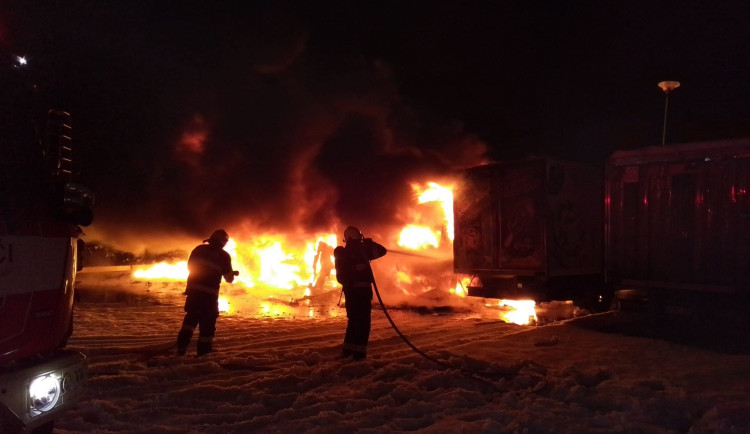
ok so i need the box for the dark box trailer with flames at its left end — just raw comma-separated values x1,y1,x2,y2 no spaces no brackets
453,157,610,318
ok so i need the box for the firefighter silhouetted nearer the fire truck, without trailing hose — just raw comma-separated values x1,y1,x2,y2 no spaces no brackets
177,229,240,356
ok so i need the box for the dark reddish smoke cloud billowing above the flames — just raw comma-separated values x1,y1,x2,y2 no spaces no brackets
76,5,487,248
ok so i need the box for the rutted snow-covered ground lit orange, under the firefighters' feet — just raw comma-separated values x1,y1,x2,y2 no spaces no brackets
55,280,750,433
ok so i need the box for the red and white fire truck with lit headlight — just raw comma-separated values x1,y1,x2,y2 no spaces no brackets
0,56,93,432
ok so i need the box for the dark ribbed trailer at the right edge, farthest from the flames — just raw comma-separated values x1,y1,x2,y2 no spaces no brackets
605,139,750,318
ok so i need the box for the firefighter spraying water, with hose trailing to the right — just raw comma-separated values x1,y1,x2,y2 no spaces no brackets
333,226,386,360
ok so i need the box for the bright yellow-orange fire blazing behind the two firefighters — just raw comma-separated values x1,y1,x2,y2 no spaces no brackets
79,182,564,324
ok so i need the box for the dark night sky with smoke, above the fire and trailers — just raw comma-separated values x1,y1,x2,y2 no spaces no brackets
0,0,750,248
